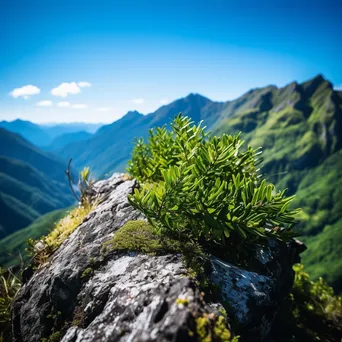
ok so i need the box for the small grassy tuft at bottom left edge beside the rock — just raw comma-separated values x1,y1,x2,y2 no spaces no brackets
0,267,21,341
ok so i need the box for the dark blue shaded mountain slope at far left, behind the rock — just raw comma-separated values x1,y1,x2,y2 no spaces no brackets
0,128,74,238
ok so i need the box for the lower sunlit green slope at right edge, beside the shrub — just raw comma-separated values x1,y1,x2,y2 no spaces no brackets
296,150,342,290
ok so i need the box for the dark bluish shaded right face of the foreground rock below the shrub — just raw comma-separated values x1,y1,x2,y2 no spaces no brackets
211,241,302,341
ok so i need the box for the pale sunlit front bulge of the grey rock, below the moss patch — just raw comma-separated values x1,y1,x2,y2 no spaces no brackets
62,255,203,342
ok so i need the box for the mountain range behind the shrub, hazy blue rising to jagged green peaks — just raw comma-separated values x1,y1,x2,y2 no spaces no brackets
0,75,342,290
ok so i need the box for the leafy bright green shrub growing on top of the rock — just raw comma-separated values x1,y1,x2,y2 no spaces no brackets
128,114,297,246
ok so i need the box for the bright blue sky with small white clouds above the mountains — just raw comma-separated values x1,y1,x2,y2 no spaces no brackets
0,0,342,122
